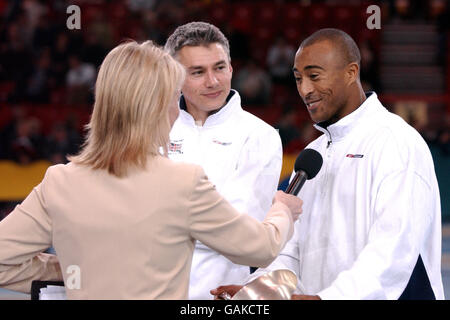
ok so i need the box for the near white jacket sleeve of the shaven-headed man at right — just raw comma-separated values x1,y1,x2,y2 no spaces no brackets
318,168,434,299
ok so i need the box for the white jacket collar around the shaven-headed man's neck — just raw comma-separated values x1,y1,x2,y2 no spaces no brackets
314,91,384,142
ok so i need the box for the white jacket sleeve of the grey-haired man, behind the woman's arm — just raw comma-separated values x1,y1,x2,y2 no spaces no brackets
221,129,283,221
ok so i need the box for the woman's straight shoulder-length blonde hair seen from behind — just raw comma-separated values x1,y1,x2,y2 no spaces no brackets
69,41,185,177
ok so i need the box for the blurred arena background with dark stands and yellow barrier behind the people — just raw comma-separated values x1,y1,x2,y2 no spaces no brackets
0,0,450,299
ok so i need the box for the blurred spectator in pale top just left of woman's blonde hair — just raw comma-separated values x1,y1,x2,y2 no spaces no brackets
66,54,96,104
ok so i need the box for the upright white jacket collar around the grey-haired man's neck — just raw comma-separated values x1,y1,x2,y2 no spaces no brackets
178,89,242,127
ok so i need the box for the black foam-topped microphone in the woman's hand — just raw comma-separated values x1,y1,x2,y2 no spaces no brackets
285,149,323,195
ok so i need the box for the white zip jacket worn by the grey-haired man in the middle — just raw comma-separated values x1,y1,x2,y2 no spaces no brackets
169,90,283,300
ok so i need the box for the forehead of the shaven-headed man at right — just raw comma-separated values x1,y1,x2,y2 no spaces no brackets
294,40,339,71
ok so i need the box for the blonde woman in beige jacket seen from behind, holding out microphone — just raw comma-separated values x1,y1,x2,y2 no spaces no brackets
0,41,302,299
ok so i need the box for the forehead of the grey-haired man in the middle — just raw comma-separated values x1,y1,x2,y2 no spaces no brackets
178,43,228,67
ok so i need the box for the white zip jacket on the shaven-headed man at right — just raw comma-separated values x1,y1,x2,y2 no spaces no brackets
248,93,444,299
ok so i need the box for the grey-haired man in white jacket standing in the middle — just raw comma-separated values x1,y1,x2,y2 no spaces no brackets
165,22,282,299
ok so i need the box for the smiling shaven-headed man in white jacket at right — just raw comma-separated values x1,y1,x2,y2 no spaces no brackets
212,29,444,299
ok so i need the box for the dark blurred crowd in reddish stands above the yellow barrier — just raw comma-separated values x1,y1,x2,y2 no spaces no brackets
0,0,450,164
